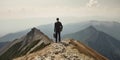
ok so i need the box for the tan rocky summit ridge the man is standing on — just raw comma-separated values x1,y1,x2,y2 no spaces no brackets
14,39,108,60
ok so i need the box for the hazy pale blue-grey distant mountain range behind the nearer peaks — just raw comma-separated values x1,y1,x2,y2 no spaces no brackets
0,21,120,42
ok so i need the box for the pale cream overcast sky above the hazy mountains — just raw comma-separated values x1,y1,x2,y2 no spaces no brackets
0,0,120,36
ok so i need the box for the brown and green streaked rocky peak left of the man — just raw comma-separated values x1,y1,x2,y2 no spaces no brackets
0,28,52,60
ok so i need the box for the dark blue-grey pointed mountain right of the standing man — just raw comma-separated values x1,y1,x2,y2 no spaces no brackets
65,26,120,60
